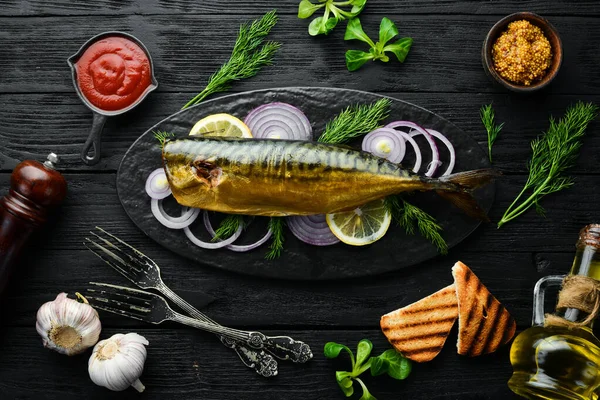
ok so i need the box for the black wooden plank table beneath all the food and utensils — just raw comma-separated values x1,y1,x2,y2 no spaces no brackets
0,0,600,400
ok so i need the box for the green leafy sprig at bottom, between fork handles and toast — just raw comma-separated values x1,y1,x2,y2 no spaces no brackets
323,339,412,400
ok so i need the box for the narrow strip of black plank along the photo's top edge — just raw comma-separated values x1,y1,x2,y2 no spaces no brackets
0,0,599,16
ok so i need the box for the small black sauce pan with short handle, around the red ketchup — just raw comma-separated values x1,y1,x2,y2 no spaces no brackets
67,31,158,165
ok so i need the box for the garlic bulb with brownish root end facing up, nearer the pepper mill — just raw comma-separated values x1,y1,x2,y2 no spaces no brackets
35,293,102,356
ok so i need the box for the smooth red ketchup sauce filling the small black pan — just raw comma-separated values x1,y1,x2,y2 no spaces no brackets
75,36,152,111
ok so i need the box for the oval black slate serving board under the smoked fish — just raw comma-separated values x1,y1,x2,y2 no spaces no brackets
117,88,495,280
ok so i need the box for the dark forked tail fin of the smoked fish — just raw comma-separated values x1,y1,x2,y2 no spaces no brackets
437,169,501,222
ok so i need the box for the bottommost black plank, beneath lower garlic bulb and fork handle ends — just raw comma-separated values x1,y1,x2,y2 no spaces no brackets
0,328,516,400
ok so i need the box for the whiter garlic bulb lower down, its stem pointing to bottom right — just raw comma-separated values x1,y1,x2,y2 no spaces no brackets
88,333,148,392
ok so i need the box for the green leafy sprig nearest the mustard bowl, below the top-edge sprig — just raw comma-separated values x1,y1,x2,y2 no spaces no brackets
344,17,413,71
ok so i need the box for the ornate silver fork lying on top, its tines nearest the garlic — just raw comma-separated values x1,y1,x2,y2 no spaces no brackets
86,282,312,363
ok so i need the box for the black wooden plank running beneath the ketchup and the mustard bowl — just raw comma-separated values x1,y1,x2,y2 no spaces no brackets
0,13,600,97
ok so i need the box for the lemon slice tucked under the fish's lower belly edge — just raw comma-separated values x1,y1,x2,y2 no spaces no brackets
326,199,392,246
